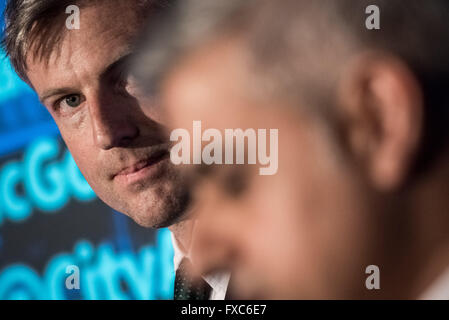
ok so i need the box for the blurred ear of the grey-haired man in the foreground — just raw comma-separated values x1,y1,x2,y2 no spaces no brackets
337,53,423,191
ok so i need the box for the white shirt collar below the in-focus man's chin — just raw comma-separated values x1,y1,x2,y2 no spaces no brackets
170,233,231,300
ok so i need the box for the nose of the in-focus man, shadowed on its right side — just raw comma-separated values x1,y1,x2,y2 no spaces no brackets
89,95,139,150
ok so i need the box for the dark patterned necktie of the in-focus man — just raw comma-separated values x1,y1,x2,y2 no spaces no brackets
174,258,212,300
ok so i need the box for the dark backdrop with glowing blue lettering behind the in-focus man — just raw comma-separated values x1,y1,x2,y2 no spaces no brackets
0,0,174,299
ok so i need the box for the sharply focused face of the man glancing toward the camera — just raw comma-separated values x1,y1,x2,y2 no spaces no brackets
27,0,187,227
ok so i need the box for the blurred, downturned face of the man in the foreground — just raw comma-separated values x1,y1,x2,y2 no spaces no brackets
162,41,382,298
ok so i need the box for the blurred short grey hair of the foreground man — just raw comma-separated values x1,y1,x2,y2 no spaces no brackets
135,0,449,175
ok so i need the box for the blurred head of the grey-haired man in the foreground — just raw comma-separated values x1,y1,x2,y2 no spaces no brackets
137,0,449,298
